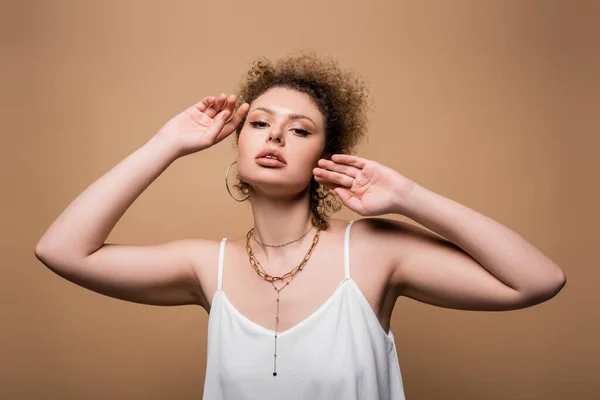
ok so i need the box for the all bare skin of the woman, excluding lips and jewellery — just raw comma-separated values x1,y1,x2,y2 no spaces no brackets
35,88,566,338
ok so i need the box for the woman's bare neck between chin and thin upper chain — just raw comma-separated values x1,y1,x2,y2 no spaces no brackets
250,186,312,245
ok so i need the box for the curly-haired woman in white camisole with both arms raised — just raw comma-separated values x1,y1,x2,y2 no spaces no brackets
36,55,565,399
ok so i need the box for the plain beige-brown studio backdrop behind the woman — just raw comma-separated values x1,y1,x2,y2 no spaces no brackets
0,0,600,400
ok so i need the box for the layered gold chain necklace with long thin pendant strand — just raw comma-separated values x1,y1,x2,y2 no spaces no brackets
246,226,321,376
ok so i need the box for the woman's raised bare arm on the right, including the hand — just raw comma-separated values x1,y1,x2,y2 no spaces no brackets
314,155,566,311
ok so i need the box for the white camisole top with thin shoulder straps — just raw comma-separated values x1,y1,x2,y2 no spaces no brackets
204,221,405,400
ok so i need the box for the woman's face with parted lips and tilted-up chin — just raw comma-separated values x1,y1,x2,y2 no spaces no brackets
238,87,325,196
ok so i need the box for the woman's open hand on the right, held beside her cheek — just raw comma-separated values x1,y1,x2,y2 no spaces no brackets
313,154,414,216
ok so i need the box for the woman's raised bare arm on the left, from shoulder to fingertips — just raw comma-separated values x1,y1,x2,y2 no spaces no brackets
35,94,248,306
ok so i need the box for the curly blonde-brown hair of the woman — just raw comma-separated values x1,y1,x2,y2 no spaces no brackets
235,53,371,229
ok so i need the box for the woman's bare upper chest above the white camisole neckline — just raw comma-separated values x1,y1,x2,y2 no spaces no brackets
209,238,395,333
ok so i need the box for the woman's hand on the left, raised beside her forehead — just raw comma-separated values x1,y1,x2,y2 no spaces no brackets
156,94,250,156
